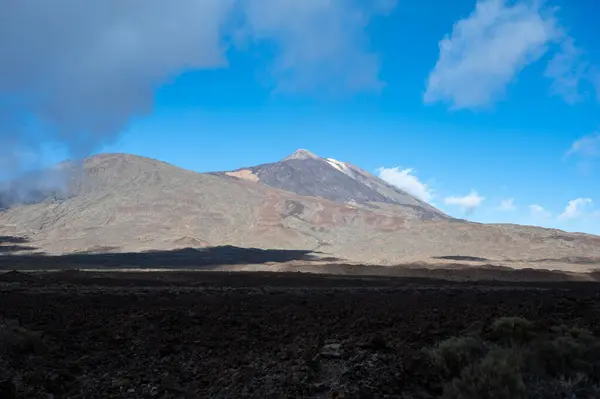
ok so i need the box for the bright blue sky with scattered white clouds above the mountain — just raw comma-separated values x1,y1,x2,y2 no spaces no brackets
0,0,600,234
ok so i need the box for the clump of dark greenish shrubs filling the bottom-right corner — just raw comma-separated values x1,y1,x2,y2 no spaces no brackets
427,317,600,399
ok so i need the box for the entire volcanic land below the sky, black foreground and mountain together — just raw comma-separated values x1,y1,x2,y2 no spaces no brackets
0,151,600,399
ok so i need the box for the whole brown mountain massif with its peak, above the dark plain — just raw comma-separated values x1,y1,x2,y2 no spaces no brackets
0,152,600,269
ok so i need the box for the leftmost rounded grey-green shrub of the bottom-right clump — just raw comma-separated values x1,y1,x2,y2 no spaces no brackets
428,336,485,377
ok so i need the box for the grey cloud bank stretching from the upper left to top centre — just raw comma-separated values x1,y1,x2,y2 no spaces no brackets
0,0,395,170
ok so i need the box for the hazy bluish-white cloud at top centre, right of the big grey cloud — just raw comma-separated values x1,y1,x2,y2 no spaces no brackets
240,0,396,91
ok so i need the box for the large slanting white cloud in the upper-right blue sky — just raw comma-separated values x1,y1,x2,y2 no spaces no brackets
424,0,561,109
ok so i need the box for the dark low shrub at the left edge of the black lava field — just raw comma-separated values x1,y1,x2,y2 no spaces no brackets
0,319,44,360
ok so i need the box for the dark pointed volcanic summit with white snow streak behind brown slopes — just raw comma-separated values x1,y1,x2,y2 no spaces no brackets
218,149,449,220
